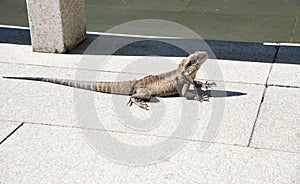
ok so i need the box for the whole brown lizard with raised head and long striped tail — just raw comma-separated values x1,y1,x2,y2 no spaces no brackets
3,51,215,110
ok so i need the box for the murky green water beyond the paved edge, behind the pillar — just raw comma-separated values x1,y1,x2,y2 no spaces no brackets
0,0,300,43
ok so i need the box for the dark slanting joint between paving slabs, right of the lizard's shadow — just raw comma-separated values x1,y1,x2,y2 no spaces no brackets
247,45,280,147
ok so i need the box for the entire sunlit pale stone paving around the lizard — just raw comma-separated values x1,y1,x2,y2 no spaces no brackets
0,32,300,184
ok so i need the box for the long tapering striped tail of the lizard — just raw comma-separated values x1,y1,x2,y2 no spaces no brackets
2,77,135,95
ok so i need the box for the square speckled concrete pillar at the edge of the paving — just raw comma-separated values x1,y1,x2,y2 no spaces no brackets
26,0,86,53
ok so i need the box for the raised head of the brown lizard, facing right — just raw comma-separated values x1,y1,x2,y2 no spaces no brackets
179,51,208,82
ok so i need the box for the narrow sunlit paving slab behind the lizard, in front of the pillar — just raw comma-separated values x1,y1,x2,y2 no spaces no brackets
0,44,271,84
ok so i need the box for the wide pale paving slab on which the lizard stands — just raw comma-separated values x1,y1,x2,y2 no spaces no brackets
0,60,264,145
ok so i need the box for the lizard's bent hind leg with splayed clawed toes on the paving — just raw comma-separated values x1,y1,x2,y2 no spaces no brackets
127,88,153,110
